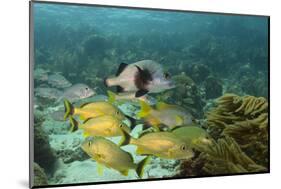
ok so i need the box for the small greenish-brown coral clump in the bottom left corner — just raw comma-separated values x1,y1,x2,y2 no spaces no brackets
33,163,48,186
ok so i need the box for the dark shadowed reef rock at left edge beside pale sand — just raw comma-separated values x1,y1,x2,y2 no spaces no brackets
34,110,56,172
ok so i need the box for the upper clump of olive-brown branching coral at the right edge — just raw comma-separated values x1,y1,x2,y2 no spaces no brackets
207,94,268,139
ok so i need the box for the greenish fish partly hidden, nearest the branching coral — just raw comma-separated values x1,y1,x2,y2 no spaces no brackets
172,125,212,149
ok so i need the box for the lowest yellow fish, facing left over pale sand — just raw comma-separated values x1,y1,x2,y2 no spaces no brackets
82,137,149,178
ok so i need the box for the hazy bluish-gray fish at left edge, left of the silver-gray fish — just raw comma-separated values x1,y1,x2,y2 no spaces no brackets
35,87,63,100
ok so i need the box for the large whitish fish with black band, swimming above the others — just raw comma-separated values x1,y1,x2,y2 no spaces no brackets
104,60,175,97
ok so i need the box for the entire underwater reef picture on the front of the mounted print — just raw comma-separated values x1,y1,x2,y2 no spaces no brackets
32,3,269,186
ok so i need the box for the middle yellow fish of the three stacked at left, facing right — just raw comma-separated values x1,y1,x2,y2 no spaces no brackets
69,115,131,143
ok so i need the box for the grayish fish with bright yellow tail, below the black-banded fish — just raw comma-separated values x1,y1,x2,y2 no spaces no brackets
137,101,195,130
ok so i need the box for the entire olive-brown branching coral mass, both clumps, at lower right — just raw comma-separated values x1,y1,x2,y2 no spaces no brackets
175,94,268,177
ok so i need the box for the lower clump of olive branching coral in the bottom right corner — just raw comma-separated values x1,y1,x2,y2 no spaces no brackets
194,137,267,174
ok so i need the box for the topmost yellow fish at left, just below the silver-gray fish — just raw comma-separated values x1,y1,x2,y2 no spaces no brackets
64,99,125,120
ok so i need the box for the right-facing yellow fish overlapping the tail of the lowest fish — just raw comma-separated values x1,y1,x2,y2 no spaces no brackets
121,132,194,159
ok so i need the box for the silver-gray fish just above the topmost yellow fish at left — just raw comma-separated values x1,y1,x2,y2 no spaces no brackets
59,83,96,102
